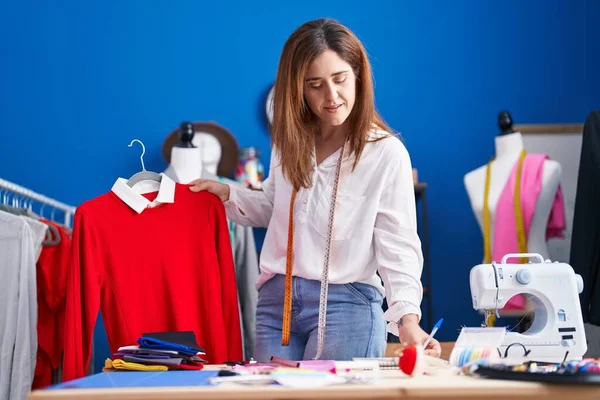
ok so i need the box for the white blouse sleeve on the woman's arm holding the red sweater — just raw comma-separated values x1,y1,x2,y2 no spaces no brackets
224,150,277,228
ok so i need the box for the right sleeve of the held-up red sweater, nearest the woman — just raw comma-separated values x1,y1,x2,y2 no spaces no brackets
211,196,243,361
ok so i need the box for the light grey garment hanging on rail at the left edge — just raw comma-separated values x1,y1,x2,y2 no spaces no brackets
0,211,45,400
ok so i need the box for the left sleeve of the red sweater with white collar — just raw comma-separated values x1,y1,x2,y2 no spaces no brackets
62,207,101,382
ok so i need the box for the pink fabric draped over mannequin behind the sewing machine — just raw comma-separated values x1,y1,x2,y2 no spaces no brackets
492,154,566,310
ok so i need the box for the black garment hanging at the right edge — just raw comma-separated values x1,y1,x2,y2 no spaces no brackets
569,110,600,326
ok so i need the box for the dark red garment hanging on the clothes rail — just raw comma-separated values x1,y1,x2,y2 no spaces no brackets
32,219,71,389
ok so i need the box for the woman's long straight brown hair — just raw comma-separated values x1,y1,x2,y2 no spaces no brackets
271,18,391,189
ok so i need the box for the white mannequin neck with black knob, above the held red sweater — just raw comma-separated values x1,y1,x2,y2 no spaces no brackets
169,122,202,183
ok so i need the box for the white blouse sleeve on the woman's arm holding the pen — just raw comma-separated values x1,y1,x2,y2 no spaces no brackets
373,144,423,336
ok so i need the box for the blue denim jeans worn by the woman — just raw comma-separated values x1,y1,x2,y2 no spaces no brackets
254,275,387,362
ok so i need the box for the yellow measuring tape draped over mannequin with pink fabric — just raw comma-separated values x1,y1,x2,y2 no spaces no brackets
483,149,527,326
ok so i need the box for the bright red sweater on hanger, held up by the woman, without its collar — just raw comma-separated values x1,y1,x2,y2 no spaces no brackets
63,184,242,381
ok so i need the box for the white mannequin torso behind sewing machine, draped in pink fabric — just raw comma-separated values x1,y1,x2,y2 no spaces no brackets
464,132,561,262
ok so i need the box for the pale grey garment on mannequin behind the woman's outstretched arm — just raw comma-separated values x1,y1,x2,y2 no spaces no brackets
164,165,260,360
